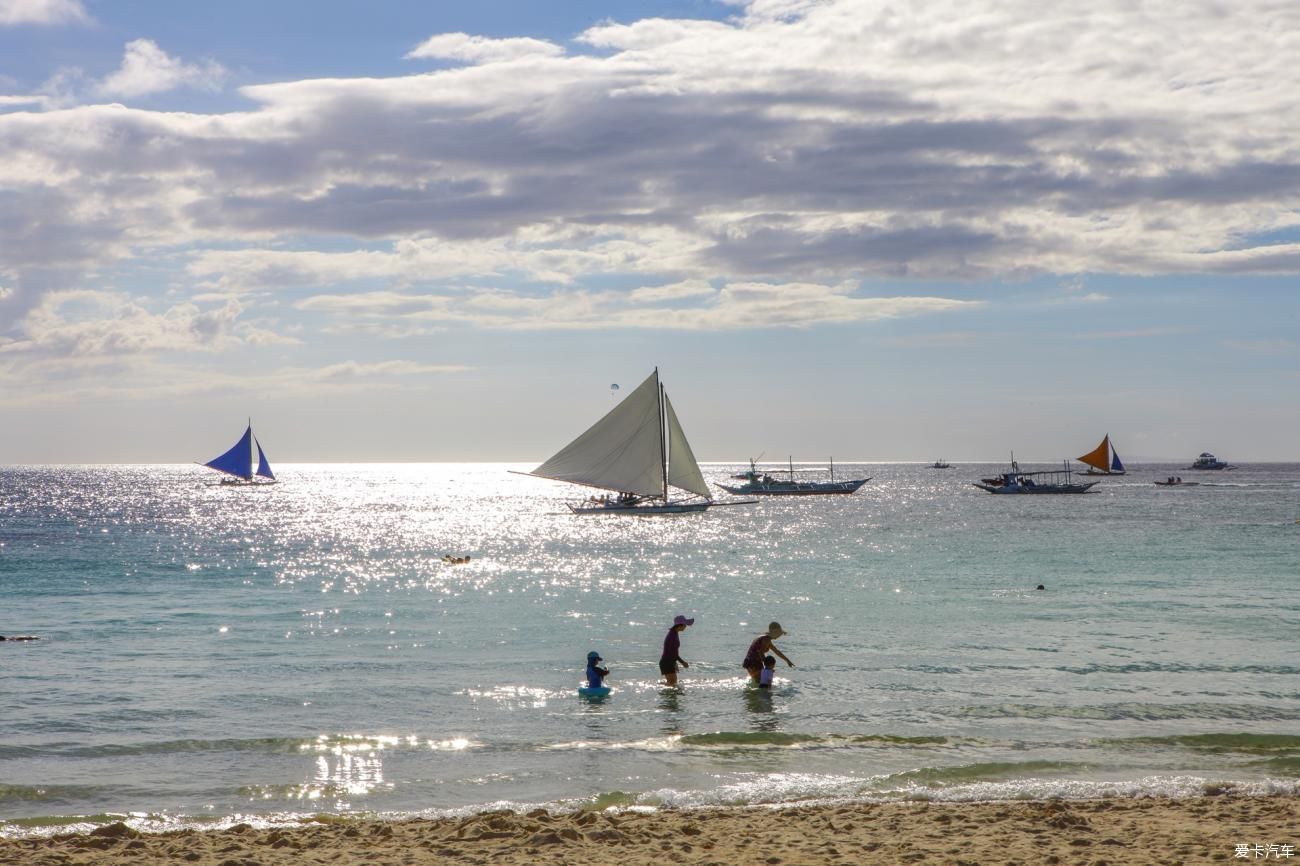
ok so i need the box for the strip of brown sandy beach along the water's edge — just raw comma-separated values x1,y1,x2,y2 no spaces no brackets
0,794,1300,866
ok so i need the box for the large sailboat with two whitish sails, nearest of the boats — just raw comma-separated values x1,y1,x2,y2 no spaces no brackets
520,367,738,515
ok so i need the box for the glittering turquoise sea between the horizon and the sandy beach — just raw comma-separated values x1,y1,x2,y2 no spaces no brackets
0,463,1300,837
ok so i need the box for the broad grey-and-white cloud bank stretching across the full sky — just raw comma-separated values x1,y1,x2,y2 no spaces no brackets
0,0,1300,384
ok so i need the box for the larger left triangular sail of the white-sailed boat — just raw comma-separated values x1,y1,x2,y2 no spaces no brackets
529,371,665,497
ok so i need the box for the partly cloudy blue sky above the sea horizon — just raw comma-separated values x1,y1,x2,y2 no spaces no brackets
0,0,1300,464
